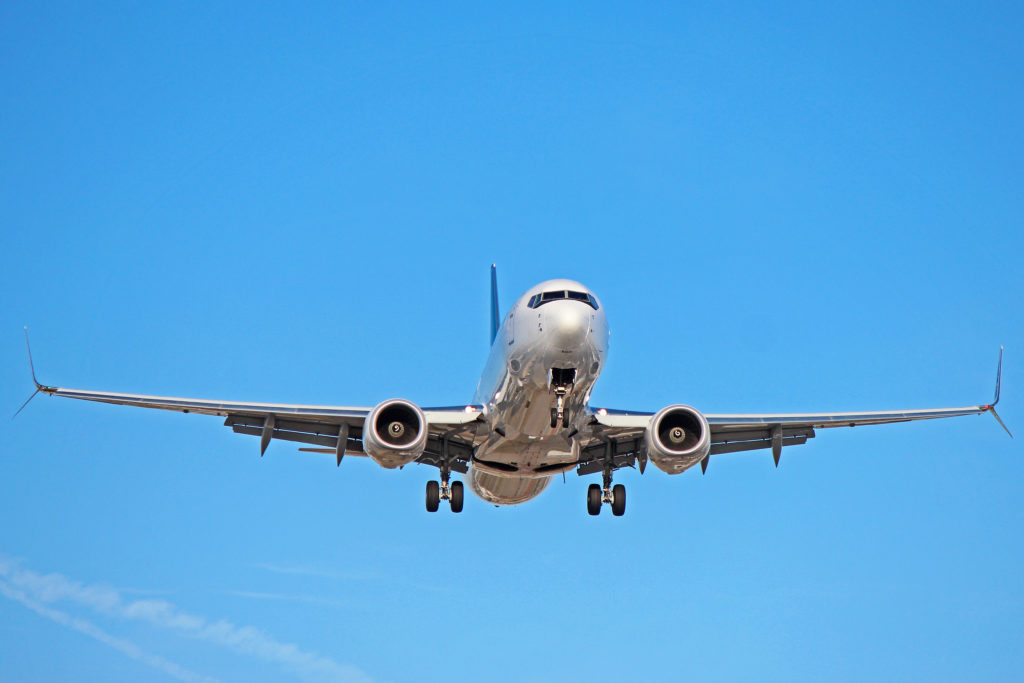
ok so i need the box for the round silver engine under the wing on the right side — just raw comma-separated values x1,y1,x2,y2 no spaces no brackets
644,405,711,474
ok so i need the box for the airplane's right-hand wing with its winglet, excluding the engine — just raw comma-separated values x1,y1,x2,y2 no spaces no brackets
577,347,1013,475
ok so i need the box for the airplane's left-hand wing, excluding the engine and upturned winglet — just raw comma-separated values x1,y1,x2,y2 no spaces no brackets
23,370,482,472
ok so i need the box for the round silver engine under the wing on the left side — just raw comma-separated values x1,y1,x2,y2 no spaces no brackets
362,398,427,469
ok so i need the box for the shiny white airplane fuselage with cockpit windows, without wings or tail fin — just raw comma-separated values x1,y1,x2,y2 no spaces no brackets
469,280,608,505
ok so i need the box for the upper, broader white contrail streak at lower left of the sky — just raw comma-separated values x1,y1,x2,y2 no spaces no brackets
0,555,372,683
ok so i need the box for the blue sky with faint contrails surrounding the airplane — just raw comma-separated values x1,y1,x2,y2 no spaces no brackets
0,2,1024,681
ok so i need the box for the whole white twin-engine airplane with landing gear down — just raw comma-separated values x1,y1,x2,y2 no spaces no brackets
15,265,1013,516
